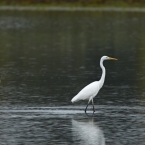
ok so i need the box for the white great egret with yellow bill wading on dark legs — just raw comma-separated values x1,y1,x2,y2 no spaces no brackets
71,56,117,113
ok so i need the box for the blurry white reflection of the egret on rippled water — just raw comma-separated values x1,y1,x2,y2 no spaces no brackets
72,118,105,145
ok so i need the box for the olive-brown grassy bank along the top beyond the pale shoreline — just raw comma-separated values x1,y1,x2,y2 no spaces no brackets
0,0,145,7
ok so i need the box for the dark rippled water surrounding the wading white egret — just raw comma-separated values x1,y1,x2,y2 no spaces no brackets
0,11,145,145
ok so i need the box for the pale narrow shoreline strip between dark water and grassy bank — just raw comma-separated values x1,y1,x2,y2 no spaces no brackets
0,6,145,12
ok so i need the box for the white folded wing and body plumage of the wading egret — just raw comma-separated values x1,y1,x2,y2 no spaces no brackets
71,81,100,102
